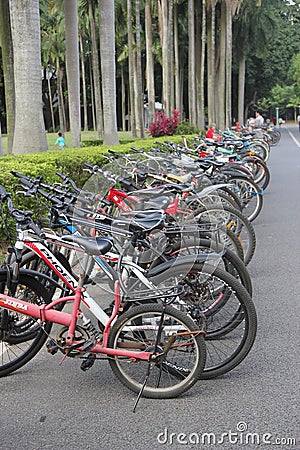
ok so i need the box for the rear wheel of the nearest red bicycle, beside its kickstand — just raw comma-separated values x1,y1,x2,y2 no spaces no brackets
108,303,206,398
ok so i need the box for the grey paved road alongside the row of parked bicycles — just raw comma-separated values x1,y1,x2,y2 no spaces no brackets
0,127,300,450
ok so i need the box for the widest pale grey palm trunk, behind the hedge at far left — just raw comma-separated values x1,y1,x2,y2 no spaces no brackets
10,0,48,154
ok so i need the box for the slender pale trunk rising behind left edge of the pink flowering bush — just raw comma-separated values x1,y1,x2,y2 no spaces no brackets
145,0,155,126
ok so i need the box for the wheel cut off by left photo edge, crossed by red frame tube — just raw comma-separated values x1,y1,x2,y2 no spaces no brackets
0,270,52,377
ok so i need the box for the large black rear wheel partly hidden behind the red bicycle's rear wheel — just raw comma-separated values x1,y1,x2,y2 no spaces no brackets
145,258,257,379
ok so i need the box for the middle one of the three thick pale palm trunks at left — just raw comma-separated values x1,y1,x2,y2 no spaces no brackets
64,0,81,148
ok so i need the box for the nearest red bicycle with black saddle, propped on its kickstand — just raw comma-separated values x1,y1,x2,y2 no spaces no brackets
0,186,206,411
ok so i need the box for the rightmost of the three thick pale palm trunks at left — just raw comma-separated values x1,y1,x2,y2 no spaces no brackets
99,0,119,145
